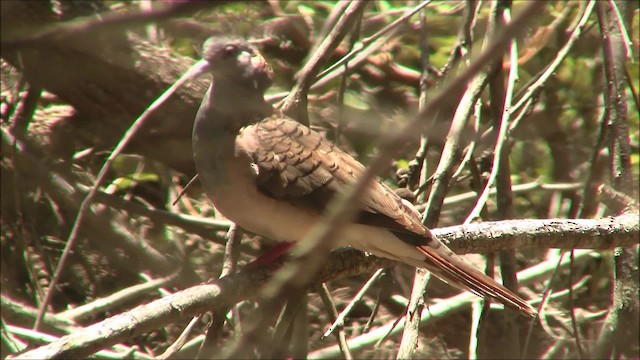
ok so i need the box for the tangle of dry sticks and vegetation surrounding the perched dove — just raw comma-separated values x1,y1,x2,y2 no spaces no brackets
0,0,640,358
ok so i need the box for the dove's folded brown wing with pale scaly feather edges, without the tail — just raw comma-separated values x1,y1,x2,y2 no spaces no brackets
238,115,431,238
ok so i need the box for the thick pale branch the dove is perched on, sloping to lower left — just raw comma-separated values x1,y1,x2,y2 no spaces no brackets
16,217,640,359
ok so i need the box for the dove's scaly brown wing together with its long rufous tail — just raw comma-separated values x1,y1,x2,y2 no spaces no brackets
236,114,535,314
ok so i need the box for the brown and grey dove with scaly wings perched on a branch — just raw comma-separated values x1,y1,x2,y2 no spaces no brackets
192,36,536,316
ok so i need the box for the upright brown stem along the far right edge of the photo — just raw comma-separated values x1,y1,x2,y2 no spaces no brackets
594,2,640,357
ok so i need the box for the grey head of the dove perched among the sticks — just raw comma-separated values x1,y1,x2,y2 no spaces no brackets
202,37,273,93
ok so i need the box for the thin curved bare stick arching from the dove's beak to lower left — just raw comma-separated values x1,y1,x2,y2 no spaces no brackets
33,62,204,330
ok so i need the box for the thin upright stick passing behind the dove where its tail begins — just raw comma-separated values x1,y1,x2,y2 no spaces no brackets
396,6,431,359
